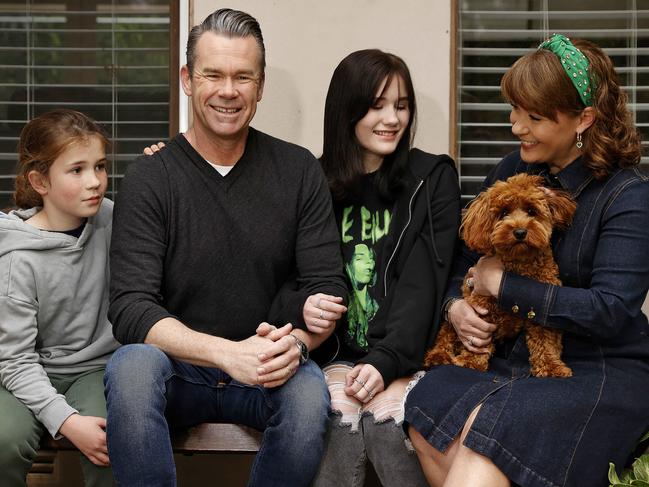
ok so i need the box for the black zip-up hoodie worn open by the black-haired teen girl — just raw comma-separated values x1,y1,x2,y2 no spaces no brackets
330,149,460,387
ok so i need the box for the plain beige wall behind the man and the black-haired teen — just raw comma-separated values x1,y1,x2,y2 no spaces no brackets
187,0,451,156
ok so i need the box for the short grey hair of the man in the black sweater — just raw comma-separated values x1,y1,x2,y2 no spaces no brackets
187,8,266,77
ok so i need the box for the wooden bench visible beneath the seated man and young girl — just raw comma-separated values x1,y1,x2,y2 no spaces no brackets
29,423,262,484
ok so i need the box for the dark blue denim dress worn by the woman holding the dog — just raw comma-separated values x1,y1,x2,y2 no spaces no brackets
405,153,649,487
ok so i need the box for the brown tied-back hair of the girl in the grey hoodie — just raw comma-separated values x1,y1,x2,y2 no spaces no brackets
13,108,109,208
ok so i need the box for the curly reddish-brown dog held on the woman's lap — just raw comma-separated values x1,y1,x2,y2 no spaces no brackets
425,174,576,377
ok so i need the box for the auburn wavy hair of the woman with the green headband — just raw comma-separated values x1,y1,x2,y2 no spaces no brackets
500,39,642,179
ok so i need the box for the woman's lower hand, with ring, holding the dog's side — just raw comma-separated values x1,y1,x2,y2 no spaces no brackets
448,299,496,353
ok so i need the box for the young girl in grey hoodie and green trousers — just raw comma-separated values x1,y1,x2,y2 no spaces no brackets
0,110,118,487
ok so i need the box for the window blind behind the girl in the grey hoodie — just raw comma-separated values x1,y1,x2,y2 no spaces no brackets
0,0,170,209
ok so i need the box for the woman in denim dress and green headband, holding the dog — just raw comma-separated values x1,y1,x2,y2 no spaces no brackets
405,35,649,487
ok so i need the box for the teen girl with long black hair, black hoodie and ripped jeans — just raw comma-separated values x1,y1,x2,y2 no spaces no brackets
305,49,460,487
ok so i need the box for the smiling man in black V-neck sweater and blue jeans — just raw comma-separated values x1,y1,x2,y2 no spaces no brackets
105,9,346,487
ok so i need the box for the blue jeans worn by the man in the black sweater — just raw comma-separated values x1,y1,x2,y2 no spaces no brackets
104,344,329,487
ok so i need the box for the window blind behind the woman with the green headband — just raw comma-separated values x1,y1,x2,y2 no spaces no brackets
457,0,649,201
